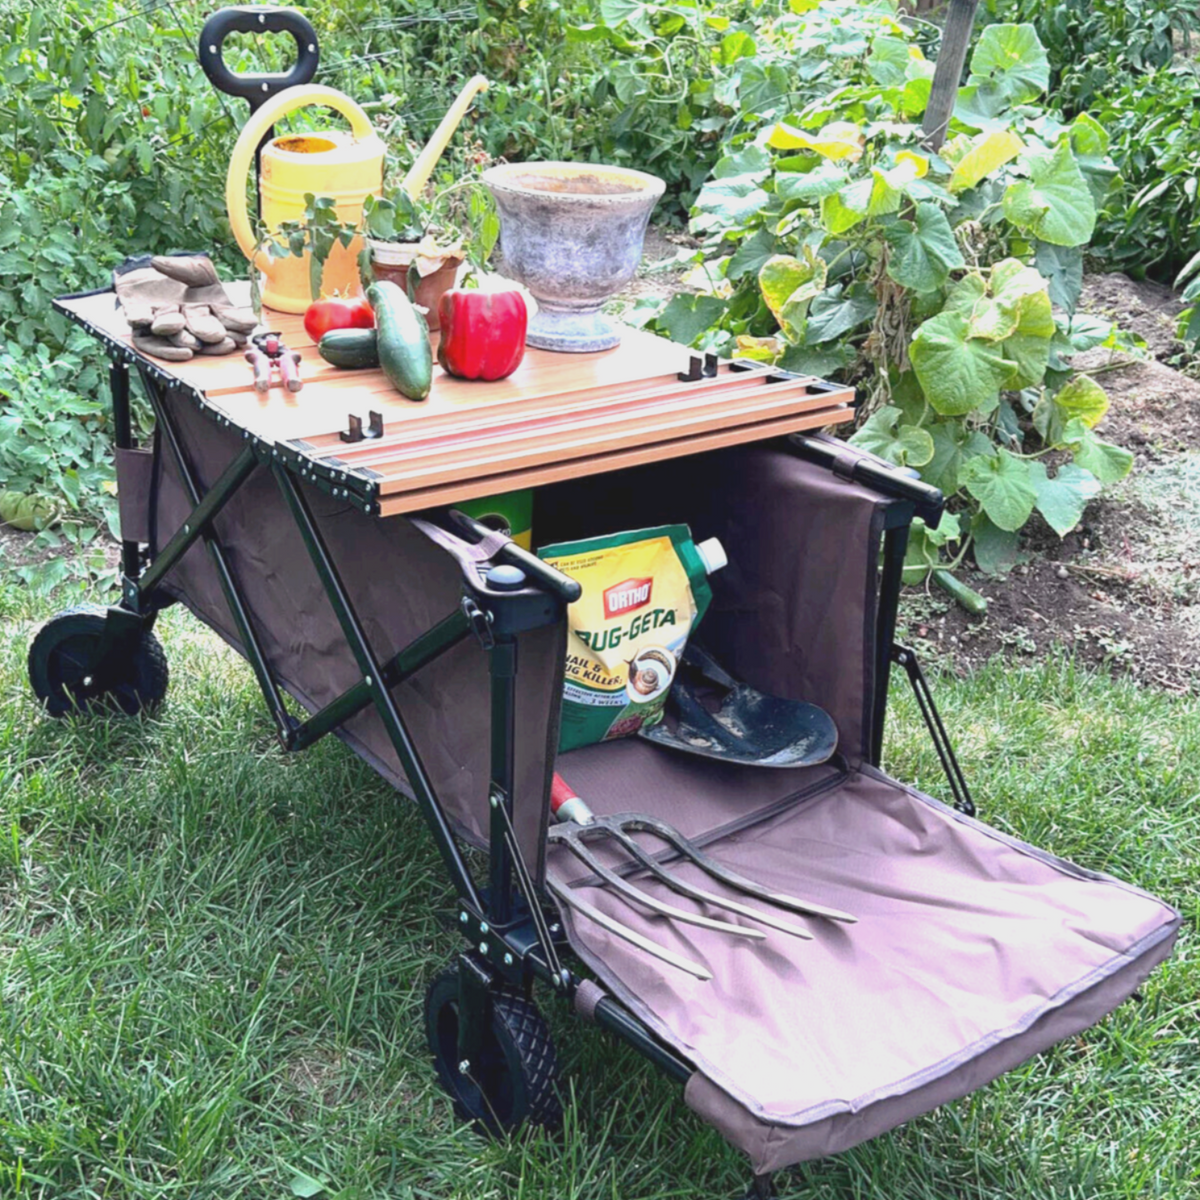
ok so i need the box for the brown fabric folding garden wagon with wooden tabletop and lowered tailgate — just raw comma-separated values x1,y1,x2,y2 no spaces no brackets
23,14,1180,1193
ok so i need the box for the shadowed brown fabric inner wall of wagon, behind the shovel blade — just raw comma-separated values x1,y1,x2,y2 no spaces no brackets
534,444,882,763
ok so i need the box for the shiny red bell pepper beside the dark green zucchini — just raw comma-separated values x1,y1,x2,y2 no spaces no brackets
438,288,529,379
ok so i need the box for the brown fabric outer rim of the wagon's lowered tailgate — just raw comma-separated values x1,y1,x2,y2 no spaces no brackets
684,924,1178,1174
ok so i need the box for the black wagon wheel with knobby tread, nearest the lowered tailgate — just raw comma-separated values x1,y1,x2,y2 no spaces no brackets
425,967,563,1134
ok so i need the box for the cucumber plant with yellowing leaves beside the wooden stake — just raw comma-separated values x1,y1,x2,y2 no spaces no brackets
654,4,1132,569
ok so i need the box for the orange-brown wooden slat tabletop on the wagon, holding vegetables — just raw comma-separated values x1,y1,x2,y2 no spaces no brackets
65,284,853,516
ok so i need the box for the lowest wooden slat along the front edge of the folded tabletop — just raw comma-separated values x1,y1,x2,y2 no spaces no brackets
379,404,854,517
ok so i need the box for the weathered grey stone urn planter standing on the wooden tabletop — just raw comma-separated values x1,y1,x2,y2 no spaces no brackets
484,162,666,353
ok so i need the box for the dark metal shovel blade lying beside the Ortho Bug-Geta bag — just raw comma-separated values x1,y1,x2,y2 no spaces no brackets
640,646,838,767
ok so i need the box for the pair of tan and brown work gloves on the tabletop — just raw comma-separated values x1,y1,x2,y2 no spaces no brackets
113,254,257,362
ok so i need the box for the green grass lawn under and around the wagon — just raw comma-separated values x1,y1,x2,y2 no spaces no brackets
0,576,1200,1200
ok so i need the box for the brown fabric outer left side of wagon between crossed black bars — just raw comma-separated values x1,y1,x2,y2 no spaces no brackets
150,401,564,871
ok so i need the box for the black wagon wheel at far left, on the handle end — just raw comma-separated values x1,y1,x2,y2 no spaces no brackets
29,605,168,716
